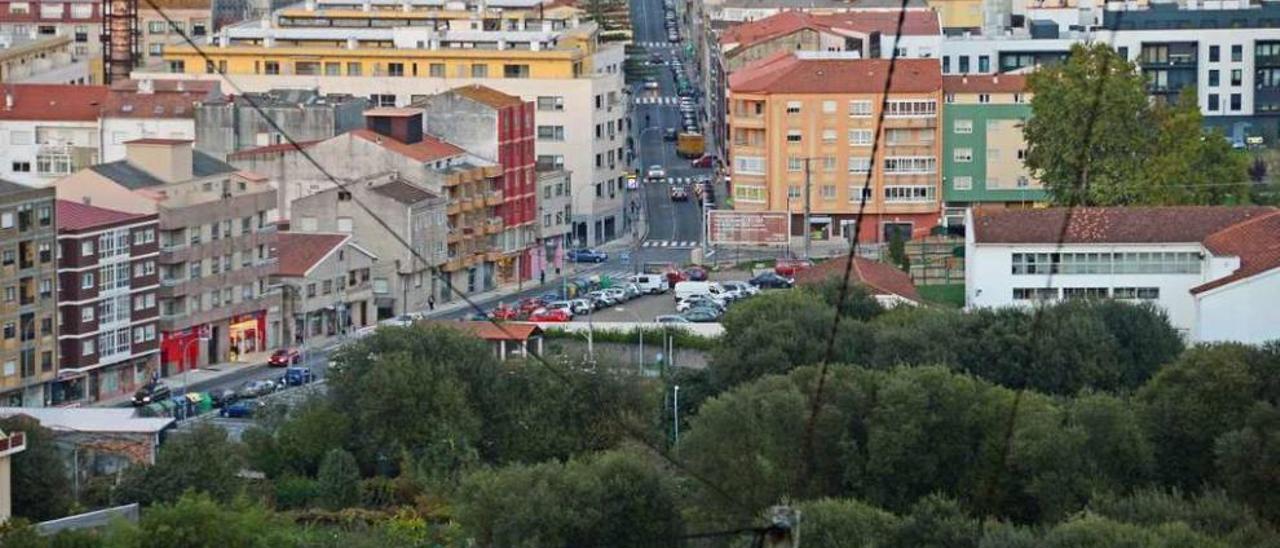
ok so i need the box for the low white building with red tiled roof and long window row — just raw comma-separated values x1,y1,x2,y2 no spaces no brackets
965,206,1280,343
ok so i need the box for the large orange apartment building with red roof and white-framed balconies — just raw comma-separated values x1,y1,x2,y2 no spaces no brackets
728,51,942,242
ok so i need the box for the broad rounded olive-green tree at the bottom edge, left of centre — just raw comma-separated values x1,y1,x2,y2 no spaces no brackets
457,451,684,547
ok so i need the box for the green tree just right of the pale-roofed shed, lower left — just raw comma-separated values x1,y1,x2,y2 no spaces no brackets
111,423,244,504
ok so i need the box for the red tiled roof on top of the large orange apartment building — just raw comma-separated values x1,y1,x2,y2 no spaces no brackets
728,51,942,93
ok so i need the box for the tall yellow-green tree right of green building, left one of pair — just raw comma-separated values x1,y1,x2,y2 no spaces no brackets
1024,42,1155,206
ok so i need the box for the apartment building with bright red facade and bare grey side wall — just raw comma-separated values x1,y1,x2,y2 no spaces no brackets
415,85,547,284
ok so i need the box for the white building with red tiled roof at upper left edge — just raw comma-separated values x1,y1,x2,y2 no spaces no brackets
0,85,108,187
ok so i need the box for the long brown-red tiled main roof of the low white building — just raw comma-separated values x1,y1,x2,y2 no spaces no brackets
972,206,1276,243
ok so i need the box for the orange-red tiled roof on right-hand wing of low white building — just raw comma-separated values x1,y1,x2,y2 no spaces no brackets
1192,211,1280,294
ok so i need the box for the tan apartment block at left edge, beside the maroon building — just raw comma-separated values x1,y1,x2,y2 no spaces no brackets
0,181,58,407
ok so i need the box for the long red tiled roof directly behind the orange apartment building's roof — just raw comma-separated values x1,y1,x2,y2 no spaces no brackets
719,10,942,47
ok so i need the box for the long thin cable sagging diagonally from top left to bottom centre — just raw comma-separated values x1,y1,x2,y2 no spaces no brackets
146,0,754,512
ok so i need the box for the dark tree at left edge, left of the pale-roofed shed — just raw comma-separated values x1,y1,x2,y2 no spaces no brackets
0,415,74,521
